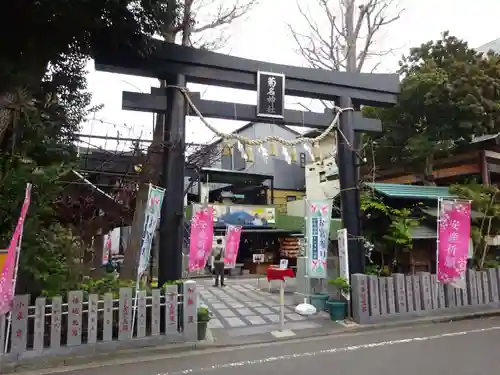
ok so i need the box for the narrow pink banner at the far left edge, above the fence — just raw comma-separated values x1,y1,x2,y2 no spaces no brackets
0,184,31,315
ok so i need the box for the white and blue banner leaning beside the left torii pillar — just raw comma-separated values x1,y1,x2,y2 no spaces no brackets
137,184,165,280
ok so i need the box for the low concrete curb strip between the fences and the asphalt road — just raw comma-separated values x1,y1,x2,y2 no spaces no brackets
5,309,500,374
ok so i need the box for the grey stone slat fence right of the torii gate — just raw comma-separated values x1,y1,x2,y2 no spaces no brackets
351,268,500,324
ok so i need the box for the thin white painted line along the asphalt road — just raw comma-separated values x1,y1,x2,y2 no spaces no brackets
157,326,500,375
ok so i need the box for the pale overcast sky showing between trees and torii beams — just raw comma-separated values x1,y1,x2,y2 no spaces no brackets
82,0,500,150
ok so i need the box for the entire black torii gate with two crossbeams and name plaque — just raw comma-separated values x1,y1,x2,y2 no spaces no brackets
95,40,399,285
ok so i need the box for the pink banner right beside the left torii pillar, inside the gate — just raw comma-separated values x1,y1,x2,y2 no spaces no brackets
188,207,214,272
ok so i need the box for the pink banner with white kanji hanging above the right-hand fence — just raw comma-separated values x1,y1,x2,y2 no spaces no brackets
436,199,471,287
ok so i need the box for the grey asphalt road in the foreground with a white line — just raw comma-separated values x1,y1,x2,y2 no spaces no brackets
17,318,500,375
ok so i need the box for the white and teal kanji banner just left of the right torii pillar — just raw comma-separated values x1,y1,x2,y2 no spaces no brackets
306,199,332,279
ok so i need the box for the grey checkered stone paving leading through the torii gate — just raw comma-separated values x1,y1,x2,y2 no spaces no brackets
197,279,335,338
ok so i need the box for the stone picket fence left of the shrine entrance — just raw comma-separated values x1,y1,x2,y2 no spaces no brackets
0,280,198,360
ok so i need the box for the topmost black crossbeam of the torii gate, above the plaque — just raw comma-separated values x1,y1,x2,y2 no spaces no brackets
95,41,400,106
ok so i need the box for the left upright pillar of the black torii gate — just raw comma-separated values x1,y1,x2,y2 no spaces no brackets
158,74,186,286
